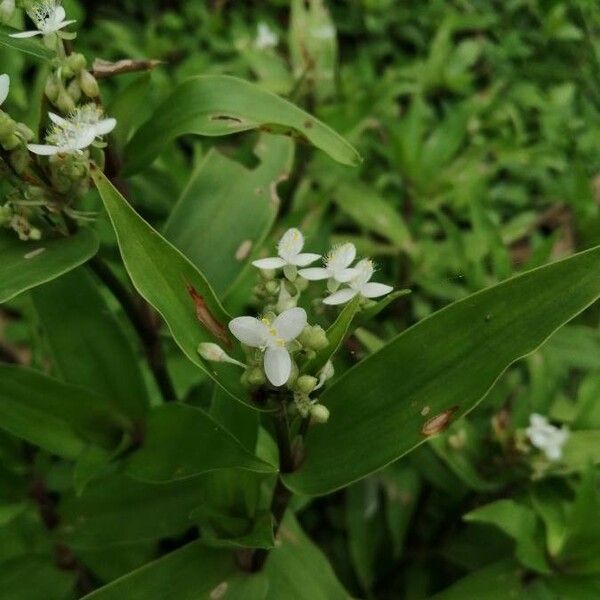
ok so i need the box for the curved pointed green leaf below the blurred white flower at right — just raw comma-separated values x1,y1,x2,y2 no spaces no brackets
464,500,551,574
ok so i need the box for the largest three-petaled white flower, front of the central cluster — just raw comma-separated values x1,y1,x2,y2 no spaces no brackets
229,308,306,386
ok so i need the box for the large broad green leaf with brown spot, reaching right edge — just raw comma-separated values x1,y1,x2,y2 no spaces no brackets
285,248,600,495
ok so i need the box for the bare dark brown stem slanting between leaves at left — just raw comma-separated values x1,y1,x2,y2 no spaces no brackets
89,255,177,402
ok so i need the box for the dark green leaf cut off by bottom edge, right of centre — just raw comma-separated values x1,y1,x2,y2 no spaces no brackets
429,561,527,600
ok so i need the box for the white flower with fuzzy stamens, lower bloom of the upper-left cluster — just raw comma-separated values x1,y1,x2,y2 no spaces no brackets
27,104,117,156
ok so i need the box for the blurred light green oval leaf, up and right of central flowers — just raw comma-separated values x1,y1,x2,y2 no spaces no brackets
333,181,412,251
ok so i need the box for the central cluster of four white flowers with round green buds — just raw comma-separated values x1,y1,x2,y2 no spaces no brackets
199,228,393,422
